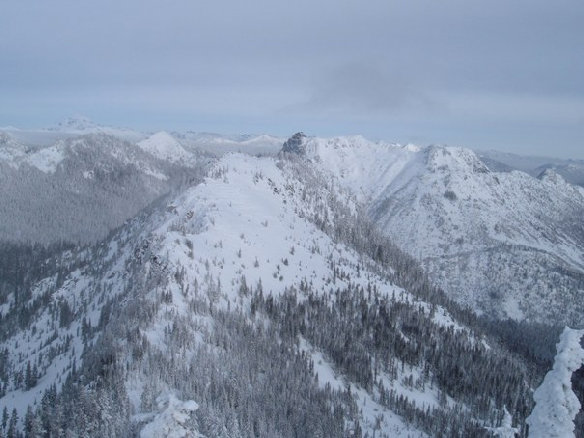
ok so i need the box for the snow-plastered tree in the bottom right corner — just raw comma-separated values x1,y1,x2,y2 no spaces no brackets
526,327,584,438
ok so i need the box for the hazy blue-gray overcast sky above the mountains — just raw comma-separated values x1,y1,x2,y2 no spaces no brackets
0,0,584,158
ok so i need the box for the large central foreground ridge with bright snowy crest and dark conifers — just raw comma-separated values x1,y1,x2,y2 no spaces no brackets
0,155,530,436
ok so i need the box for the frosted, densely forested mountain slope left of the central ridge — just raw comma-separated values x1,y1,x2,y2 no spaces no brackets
0,134,208,244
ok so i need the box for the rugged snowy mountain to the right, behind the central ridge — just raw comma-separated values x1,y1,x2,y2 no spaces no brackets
296,137,584,326
